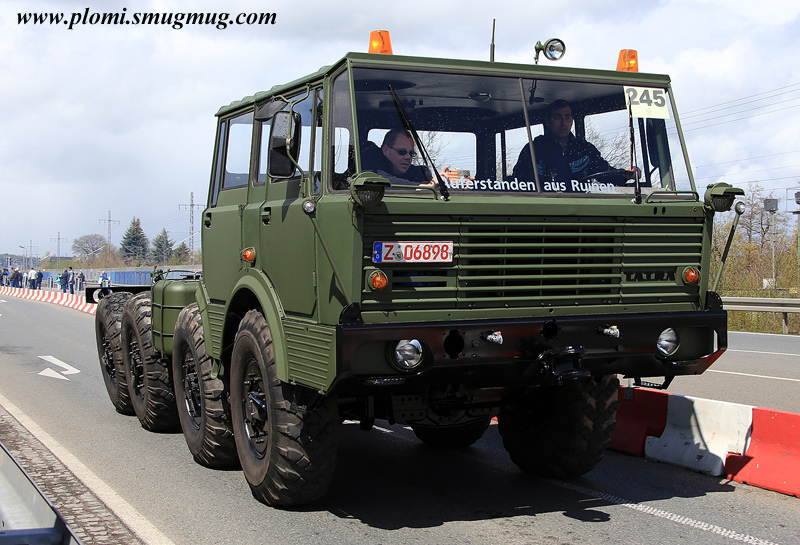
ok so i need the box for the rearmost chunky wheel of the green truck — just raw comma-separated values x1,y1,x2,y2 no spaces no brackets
94,291,135,415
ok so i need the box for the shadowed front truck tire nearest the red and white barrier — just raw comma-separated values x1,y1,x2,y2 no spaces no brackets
497,375,619,479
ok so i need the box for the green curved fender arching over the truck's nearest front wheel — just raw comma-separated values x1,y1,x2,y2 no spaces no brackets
196,269,289,382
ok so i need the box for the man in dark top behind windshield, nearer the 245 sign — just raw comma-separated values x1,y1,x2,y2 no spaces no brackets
512,99,639,191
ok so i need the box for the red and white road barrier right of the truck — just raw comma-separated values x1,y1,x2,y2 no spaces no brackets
609,386,800,498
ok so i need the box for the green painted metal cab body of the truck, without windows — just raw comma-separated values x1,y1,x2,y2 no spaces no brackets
147,53,736,392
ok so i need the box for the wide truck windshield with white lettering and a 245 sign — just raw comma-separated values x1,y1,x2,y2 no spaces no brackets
344,68,693,197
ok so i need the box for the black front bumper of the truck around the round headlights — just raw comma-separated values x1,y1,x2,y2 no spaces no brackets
337,310,727,385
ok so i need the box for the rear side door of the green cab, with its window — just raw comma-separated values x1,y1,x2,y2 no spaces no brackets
202,111,253,306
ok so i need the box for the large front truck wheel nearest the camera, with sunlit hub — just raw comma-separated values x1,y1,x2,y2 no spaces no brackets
231,310,339,507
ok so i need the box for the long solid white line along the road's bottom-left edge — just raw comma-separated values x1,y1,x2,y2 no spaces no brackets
0,394,175,545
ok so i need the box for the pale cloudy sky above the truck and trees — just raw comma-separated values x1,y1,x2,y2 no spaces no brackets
0,0,800,257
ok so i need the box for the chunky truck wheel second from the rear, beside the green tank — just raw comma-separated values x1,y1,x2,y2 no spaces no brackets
122,292,180,432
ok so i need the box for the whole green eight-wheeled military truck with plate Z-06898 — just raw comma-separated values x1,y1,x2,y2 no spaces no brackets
90,37,742,506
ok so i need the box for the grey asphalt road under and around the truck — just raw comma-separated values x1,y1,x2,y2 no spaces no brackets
0,298,800,545
